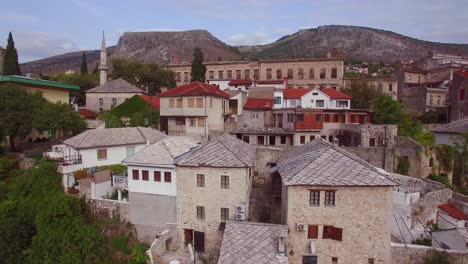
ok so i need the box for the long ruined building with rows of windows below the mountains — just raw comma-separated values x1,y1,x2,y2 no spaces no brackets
166,57,344,88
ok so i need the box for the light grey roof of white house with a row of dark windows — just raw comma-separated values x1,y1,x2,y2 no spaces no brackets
123,137,198,165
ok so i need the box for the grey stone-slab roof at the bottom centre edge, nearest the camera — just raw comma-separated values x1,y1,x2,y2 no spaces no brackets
218,222,288,264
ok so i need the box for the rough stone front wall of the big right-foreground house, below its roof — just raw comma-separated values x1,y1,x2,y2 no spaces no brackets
287,186,392,264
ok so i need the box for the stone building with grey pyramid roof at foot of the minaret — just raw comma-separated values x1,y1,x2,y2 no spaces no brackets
86,78,145,113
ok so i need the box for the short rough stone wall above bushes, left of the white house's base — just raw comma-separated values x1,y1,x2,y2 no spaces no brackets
88,199,130,222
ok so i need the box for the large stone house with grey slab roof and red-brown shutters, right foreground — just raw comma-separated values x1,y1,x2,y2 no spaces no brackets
277,140,396,264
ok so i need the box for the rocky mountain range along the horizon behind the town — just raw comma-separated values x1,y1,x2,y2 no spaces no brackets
21,26,468,73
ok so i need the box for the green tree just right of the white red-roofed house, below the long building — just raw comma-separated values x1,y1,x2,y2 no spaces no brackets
342,80,383,109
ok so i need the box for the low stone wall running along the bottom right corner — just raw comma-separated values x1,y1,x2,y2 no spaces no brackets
391,243,468,264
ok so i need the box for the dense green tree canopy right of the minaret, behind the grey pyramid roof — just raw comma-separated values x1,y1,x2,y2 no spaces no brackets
112,59,176,95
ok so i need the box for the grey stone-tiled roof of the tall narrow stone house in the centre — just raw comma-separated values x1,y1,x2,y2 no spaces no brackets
177,134,256,168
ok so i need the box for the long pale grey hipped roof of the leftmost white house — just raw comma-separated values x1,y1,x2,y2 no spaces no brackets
63,127,166,149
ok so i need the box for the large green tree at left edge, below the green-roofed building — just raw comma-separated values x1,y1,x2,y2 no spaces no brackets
0,85,45,152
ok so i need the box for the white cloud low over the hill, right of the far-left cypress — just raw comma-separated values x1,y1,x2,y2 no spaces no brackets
13,32,79,62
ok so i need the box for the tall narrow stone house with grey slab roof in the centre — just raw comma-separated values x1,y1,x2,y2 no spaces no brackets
177,135,256,263
